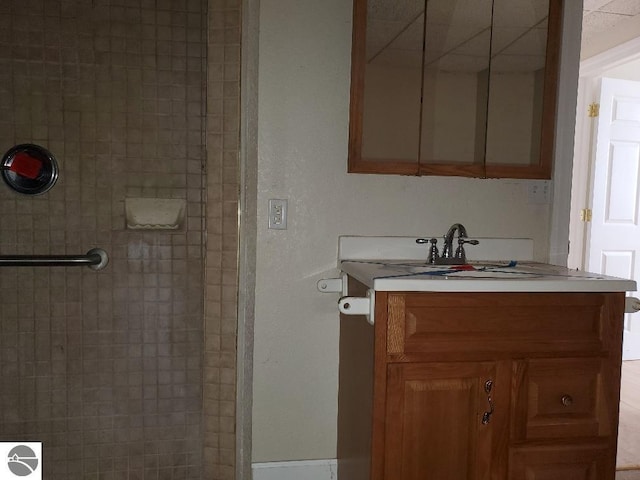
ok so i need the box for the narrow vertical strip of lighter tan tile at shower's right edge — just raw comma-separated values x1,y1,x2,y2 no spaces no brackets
203,0,241,480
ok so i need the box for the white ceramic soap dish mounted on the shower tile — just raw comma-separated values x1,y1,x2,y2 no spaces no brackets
124,198,187,230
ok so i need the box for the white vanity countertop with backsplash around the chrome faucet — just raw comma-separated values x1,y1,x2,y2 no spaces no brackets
338,236,636,292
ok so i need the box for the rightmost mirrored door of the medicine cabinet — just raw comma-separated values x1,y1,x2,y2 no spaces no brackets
486,0,560,178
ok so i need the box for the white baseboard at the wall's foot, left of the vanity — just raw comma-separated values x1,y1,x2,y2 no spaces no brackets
252,459,338,480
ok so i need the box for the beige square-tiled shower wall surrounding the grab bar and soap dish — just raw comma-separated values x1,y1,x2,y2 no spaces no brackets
0,0,241,480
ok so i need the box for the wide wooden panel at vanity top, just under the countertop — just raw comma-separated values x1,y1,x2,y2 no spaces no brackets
386,292,618,355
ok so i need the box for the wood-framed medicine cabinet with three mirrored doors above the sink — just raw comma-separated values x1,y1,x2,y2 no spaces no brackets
349,0,562,179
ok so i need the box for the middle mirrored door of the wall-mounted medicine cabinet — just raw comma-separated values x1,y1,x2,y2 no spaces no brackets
420,0,492,176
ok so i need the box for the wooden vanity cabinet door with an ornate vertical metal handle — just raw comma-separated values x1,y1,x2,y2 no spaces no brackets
384,363,498,480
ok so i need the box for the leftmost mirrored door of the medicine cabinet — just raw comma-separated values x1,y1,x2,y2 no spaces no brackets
350,0,424,174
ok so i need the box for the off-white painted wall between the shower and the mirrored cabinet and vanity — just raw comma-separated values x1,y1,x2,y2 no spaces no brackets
253,0,580,462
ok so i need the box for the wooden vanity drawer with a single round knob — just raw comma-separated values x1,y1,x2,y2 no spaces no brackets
511,358,617,441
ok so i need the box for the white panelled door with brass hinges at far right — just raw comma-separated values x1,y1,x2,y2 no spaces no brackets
586,78,640,360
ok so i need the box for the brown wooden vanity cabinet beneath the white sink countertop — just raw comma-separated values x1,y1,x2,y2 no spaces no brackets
338,281,624,480
